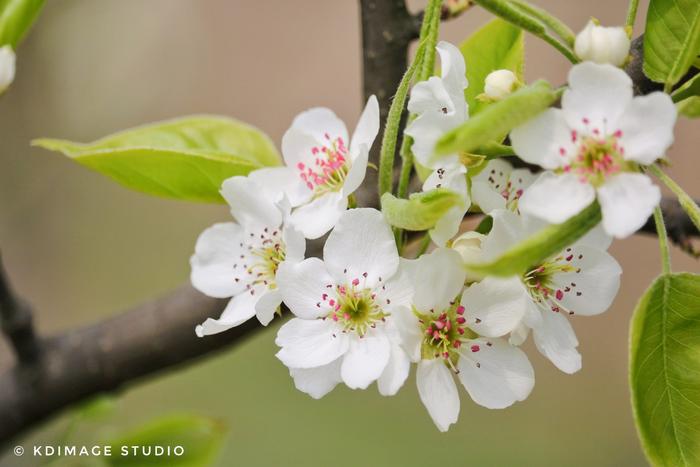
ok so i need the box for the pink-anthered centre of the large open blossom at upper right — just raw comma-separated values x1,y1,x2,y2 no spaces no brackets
559,129,633,187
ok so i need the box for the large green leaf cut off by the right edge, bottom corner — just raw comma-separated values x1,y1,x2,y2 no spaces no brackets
630,273,700,467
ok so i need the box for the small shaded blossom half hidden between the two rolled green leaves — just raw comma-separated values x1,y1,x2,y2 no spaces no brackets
471,159,536,214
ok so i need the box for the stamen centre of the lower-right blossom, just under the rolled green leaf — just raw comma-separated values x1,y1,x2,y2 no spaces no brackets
523,248,583,315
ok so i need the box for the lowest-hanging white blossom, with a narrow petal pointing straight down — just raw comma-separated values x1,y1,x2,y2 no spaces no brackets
394,248,535,431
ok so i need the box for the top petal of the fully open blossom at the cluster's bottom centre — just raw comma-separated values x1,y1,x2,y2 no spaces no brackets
323,208,399,288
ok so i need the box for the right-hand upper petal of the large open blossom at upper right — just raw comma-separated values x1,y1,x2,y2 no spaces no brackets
618,92,677,165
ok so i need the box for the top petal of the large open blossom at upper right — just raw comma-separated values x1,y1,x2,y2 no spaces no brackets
561,62,632,136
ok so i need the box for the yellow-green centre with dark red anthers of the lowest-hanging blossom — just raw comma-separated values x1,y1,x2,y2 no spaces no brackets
413,300,479,372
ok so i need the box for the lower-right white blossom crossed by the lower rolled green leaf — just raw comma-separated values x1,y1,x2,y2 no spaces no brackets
462,210,622,373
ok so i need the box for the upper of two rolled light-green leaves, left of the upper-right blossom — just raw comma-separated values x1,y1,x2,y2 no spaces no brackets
435,81,559,155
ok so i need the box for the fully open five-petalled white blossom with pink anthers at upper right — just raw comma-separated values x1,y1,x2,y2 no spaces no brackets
510,62,676,238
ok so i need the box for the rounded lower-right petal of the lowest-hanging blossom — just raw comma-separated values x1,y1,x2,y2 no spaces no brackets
457,339,535,409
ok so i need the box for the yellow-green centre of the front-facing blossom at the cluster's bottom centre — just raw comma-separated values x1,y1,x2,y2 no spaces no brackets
316,279,391,337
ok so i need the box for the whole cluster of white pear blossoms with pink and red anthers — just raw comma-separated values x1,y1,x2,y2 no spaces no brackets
191,39,676,431
